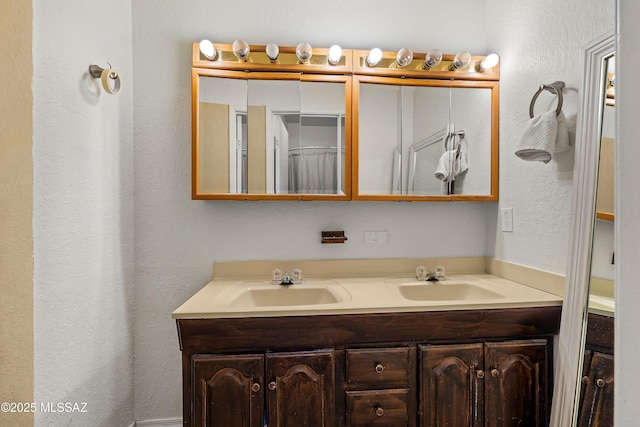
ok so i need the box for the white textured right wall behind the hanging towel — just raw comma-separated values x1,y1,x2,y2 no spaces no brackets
487,0,614,273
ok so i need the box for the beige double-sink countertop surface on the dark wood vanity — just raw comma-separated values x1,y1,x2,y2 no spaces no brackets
173,264,562,319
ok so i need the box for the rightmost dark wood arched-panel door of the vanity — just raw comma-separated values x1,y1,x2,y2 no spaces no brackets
484,340,548,427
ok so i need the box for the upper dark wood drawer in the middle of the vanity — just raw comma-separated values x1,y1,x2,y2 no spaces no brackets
346,347,415,389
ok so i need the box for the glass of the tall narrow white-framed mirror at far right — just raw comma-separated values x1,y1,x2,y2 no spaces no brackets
577,55,615,427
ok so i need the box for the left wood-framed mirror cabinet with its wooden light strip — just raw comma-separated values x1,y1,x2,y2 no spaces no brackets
192,43,351,200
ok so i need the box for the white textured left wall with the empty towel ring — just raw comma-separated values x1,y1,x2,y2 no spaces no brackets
33,0,133,426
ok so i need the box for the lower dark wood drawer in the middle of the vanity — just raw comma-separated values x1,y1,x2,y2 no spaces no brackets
347,389,409,426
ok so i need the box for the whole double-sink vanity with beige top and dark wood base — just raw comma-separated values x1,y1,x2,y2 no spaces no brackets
173,257,562,427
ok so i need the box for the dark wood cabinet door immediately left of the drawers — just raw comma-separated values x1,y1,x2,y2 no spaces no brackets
266,350,336,427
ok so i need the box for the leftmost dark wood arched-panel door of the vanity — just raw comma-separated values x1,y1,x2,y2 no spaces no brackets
191,355,264,427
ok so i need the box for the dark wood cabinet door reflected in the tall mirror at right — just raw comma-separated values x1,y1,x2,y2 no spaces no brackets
578,352,613,427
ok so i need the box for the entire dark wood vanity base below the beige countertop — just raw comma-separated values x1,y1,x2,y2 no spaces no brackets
177,307,560,427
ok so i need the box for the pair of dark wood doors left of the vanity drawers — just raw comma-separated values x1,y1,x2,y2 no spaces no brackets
192,350,336,427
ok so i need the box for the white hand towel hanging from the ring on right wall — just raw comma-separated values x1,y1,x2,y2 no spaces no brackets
516,110,558,163
